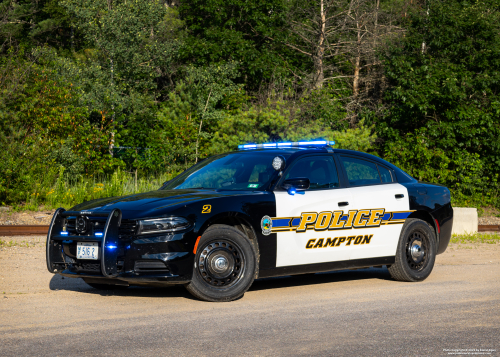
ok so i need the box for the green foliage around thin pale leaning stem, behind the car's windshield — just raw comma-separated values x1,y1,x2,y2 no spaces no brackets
147,63,244,168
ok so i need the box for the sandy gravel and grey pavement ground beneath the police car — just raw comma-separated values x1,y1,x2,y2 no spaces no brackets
0,236,500,357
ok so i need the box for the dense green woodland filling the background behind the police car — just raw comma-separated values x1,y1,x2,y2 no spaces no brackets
0,0,500,209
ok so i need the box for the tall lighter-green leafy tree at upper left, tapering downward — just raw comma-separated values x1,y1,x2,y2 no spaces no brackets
60,0,182,169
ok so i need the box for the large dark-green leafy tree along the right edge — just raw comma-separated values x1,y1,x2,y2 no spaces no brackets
377,0,500,204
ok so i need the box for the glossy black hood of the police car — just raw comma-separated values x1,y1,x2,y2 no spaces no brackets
70,189,247,218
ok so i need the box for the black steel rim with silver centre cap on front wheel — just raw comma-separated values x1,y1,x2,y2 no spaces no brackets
198,240,245,287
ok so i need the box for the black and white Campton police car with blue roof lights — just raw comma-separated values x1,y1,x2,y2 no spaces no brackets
47,141,453,301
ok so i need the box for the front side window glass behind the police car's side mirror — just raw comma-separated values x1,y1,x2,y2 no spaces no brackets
285,156,340,190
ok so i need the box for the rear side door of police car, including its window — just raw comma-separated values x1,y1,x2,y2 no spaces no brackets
340,155,411,260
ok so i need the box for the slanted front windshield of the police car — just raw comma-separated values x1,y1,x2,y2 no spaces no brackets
161,152,288,191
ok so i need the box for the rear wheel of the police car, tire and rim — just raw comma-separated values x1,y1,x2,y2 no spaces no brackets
389,218,436,282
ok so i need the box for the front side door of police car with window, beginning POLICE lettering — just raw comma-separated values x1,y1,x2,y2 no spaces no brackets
272,154,352,267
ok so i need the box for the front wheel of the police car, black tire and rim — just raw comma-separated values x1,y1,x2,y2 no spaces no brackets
186,224,257,302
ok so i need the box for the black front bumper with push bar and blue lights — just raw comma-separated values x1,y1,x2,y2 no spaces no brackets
46,208,196,284
